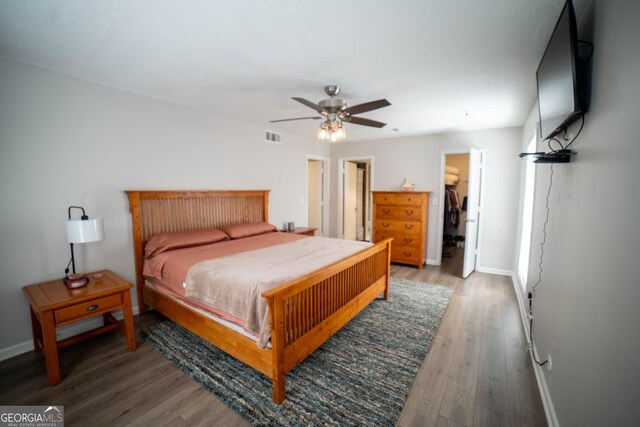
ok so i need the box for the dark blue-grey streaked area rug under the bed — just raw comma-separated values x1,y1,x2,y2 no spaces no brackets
141,278,452,426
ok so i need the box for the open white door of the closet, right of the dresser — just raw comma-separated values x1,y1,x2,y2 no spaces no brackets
462,148,482,278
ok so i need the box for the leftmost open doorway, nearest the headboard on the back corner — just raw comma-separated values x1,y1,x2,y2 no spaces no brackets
307,155,329,236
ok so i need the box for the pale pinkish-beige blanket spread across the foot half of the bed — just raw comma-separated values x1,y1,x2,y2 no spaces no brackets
185,237,371,348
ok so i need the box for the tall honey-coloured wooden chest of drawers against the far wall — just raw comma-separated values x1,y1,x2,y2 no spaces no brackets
373,191,429,269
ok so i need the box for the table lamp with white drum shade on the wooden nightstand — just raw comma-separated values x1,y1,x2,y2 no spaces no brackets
63,206,104,289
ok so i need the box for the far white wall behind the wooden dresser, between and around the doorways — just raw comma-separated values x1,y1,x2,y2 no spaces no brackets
331,127,521,271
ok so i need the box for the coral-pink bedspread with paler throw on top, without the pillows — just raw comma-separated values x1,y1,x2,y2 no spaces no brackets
143,232,370,347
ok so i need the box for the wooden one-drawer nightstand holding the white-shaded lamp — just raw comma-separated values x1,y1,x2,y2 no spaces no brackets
22,270,136,386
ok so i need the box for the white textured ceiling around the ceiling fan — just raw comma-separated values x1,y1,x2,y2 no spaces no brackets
0,0,563,140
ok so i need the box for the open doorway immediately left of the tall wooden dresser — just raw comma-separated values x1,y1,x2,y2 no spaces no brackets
338,157,373,241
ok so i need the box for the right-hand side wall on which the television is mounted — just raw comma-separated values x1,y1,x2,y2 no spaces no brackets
525,1,640,426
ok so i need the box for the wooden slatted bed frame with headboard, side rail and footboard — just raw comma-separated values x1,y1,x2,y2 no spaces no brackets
126,190,391,404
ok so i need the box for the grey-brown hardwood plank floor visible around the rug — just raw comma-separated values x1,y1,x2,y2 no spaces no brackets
0,248,546,426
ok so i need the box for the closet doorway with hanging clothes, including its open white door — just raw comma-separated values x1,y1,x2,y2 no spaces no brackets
438,148,485,278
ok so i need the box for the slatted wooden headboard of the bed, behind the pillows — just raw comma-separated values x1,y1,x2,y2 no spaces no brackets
125,190,269,313
